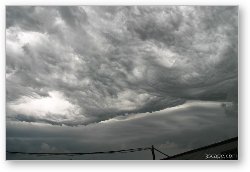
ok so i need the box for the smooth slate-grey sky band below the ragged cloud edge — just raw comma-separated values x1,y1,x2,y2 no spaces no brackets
7,101,237,159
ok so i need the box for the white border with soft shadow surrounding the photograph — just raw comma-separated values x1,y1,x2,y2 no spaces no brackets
0,0,250,172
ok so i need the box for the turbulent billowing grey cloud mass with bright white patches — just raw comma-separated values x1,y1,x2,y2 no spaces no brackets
6,6,238,126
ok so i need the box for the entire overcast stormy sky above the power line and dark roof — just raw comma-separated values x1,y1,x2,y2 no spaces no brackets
6,6,238,159
